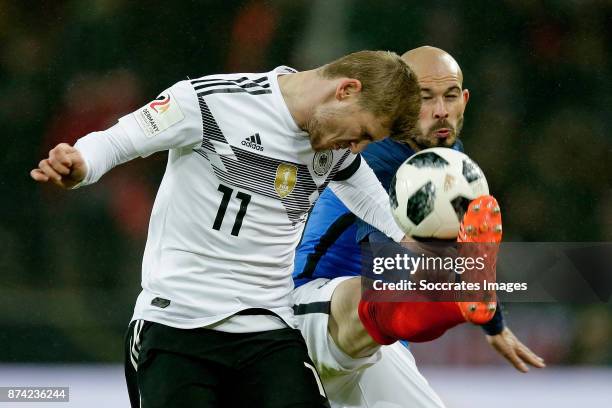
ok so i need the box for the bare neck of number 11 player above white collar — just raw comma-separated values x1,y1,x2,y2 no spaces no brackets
278,70,335,129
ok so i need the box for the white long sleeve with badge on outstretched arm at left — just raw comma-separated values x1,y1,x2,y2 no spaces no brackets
74,81,203,187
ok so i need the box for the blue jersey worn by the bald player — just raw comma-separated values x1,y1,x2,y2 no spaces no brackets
293,138,463,287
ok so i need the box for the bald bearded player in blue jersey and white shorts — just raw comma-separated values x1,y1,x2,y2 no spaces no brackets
294,47,544,407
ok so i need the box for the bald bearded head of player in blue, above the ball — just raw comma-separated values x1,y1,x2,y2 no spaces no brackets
402,46,470,151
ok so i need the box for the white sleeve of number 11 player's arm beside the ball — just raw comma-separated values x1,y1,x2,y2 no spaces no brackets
329,160,406,242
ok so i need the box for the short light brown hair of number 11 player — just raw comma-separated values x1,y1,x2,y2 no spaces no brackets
319,51,421,141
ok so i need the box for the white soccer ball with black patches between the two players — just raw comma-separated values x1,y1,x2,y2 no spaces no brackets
389,147,489,239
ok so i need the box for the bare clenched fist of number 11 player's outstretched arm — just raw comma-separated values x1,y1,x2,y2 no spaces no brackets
30,143,87,188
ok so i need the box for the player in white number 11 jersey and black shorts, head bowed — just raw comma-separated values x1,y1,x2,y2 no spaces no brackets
31,51,420,408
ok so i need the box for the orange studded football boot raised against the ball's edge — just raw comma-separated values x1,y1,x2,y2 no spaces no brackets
456,195,502,324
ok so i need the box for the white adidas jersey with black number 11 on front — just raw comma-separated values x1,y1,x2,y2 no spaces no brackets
119,67,359,328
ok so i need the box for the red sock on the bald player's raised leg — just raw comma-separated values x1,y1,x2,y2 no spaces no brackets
359,300,466,345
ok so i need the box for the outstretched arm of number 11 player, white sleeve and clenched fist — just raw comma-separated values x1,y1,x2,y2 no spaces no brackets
30,81,202,188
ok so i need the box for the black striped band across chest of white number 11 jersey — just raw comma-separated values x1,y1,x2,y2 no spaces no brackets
193,98,350,225
